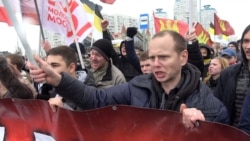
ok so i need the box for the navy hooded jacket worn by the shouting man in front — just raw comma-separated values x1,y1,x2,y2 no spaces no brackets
56,64,228,123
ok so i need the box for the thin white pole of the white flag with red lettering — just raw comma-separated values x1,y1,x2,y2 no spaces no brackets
65,0,85,69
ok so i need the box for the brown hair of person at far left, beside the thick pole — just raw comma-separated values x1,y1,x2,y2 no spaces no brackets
5,54,25,72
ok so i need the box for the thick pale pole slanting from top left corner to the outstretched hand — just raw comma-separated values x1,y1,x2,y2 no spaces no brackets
2,0,38,67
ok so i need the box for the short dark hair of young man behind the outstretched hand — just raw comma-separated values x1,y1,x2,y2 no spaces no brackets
47,46,77,66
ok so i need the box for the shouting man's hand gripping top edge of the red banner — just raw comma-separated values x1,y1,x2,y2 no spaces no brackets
180,104,205,128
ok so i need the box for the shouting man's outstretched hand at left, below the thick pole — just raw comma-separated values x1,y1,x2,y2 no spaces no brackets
27,55,61,86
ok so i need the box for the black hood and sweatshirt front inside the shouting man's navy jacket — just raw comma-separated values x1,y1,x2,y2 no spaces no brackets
150,63,201,111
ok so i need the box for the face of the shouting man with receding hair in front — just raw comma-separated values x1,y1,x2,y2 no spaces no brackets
149,34,188,83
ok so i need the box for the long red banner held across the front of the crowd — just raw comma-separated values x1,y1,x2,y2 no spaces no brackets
0,99,250,141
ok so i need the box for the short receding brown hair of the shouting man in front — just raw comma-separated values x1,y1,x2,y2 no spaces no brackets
152,30,187,53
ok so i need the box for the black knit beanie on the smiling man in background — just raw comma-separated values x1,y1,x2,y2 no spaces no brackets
92,39,113,60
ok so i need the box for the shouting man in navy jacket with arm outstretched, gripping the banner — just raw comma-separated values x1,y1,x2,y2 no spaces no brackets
29,30,228,128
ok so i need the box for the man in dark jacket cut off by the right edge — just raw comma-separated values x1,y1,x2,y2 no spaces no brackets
214,25,250,133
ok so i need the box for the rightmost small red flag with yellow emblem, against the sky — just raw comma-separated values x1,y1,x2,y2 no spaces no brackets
214,13,235,36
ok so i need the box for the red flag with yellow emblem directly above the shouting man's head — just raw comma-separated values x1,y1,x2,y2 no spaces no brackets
153,14,188,36
